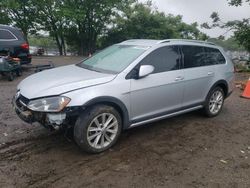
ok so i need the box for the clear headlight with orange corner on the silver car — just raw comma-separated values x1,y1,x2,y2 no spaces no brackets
27,96,70,112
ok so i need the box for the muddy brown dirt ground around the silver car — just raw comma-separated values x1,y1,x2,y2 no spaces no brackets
0,57,250,188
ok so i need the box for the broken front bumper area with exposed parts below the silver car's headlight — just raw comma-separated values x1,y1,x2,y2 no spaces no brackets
12,95,80,130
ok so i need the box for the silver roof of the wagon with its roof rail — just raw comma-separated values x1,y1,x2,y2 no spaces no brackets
119,39,217,48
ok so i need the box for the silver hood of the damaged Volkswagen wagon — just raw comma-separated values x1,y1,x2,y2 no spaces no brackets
17,65,116,99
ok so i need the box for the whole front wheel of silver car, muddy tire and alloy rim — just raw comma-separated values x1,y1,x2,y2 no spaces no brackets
74,105,122,153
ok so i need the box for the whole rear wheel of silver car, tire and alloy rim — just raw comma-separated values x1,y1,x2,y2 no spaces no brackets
204,87,225,117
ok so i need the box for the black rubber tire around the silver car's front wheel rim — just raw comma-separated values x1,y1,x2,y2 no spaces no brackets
74,105,122,153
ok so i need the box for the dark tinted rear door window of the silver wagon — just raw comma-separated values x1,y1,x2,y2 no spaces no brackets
182,45,206,68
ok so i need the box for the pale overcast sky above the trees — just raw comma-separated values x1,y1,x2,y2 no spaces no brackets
139,0,250,38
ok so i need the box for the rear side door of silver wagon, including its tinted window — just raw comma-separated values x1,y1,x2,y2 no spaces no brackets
181,45,215,107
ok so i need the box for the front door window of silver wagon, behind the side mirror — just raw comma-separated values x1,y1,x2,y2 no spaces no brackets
140,46,180,73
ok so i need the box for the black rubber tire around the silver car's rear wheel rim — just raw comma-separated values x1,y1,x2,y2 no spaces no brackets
204,87,225,117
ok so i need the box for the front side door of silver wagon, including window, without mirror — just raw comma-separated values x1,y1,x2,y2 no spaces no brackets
130,46,184,123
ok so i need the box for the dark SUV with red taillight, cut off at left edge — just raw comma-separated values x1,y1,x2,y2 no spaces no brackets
0,24,31,64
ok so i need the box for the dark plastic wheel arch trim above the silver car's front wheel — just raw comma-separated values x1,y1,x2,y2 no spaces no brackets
83,96,129,129
